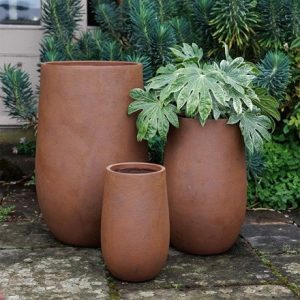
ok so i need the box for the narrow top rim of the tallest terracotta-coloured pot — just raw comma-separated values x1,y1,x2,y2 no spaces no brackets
41,60,142,68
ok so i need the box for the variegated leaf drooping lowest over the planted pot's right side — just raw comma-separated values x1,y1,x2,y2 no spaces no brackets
228,111,272,153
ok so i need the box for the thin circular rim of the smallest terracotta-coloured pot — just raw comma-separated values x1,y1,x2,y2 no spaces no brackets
106,162,166,176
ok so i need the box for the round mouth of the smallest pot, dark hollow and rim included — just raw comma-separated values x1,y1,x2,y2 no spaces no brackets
106,162,165,175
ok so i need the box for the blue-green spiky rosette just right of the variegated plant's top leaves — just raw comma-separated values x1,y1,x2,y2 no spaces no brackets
255,52,290,101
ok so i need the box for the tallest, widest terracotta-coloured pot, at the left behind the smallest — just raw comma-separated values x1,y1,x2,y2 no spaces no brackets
36,61,147,246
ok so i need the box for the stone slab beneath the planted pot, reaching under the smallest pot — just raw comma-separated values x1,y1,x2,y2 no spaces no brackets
114,245,276,291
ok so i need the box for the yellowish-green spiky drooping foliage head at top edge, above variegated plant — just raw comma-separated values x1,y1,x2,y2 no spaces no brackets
209,0,258,50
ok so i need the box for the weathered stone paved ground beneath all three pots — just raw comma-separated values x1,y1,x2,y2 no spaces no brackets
0,186,300,300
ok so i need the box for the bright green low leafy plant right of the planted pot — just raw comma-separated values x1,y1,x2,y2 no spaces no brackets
248,142,300,210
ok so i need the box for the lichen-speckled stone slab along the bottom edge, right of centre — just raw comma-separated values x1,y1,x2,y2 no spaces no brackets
120,285,297,300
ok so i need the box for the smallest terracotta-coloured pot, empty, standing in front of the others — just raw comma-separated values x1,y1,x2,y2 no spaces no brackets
101,163,170,281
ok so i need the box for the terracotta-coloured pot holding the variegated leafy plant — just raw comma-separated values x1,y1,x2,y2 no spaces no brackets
165,118,247,255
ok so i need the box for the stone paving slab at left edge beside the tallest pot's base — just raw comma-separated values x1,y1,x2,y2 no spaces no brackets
0,222,64,249
